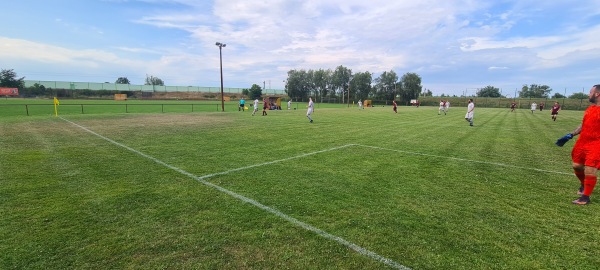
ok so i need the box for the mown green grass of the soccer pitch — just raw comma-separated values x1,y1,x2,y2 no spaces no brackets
0,101,600,269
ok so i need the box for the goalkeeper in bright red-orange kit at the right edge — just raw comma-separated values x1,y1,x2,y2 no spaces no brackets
556,84,600,205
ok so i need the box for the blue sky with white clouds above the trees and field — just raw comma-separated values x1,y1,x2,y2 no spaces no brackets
0,0,600,96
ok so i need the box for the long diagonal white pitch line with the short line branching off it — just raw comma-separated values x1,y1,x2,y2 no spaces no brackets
60,117,410,269
